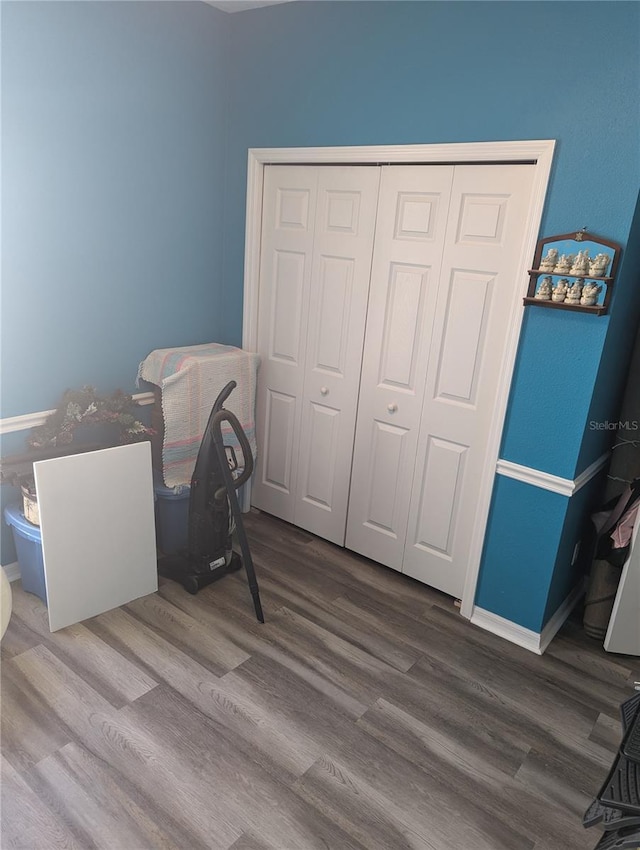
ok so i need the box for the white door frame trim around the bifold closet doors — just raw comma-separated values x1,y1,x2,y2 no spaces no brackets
242,139,555,619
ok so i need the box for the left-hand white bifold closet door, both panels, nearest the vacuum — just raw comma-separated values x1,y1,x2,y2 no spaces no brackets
252,166,380,544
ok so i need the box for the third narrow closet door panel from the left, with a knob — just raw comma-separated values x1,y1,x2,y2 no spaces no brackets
346,166,454,570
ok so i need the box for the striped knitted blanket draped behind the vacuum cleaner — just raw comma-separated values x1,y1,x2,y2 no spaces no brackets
138,343,260,487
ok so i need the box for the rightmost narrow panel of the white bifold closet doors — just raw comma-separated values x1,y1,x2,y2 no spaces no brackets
403,165,534,597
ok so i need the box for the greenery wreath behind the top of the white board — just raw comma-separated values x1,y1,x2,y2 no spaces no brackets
27,386,155,449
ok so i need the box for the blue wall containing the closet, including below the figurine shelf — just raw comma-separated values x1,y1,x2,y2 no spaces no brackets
224,2,640,631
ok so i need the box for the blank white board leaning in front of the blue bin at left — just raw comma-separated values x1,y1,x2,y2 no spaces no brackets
33,442,158,632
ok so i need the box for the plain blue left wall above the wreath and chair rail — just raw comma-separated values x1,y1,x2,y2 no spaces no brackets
1,2,229,417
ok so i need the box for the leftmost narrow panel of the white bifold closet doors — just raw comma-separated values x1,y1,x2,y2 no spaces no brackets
251,166,318,522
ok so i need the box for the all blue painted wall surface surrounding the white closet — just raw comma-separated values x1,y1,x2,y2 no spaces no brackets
2,2,640,629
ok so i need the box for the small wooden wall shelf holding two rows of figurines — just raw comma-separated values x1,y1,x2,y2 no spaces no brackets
524,231,620,315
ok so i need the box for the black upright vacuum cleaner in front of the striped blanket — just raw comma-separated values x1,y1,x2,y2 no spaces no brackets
158,381,264,623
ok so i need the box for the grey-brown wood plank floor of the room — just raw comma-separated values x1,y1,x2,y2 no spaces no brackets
1,514,640,850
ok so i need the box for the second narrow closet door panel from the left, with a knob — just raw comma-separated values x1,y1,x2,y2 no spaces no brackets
293,166,380,545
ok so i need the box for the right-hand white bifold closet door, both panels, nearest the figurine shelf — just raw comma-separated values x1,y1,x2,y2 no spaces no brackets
346,165,534,596
